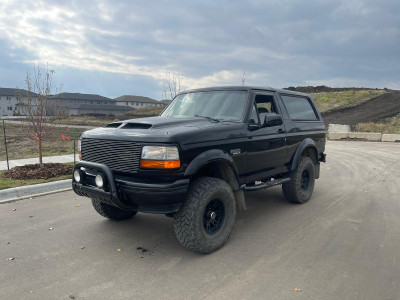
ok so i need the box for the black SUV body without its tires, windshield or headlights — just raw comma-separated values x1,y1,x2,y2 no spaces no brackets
72,86,326,252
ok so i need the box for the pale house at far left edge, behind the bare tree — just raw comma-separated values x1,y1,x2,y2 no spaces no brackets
0,88,37,116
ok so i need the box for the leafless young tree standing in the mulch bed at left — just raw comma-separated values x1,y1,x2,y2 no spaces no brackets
18,64,57,168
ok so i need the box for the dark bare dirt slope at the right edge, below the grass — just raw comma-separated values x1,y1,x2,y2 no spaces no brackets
322,91,400,125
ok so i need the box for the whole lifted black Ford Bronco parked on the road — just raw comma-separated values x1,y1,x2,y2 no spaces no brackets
72,86,325,253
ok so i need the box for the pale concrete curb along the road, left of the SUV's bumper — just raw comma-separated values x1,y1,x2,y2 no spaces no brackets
0,179,72,204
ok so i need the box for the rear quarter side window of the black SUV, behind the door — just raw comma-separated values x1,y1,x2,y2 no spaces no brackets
281,95,318,121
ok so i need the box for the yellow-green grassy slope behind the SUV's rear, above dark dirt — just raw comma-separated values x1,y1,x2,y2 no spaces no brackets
311,90,386,112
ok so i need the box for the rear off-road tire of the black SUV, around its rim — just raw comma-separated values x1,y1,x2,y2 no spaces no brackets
282,156,315,204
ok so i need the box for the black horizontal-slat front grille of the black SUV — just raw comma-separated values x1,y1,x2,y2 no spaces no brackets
81,139,142,172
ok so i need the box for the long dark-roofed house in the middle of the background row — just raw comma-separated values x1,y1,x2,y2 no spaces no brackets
48,93,134,116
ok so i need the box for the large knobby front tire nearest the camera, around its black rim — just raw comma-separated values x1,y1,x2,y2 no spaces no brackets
174,177,236,253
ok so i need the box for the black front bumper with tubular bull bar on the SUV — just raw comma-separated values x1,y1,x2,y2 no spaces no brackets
72,161,189,214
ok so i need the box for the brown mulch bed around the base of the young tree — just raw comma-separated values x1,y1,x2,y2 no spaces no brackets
2,163,72,180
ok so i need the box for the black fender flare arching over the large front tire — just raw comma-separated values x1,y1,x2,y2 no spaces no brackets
184,149,238,178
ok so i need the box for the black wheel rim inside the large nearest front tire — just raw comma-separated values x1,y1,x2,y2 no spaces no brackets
203,199,225,235
